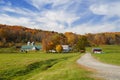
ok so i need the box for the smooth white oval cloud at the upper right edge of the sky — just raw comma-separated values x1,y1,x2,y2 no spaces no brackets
90,2,120,16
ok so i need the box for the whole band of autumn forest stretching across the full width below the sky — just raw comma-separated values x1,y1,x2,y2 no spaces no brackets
0,24,120,50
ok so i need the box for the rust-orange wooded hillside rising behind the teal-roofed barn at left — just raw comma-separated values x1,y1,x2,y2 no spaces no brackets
0,24,60,47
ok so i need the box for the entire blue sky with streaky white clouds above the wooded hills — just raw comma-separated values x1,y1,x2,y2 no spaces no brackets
0,0,120,34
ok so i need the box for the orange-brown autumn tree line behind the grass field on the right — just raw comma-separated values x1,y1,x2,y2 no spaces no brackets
86,32,120,46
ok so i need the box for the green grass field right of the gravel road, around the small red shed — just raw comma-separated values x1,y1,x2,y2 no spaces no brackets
88,45,120,66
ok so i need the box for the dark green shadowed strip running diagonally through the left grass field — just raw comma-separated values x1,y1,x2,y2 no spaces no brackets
0,56,72,80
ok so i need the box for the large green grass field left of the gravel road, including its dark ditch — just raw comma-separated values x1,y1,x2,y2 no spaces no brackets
0,52,95,80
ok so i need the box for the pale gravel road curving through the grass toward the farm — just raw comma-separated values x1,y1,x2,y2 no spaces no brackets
77,53,120,80
